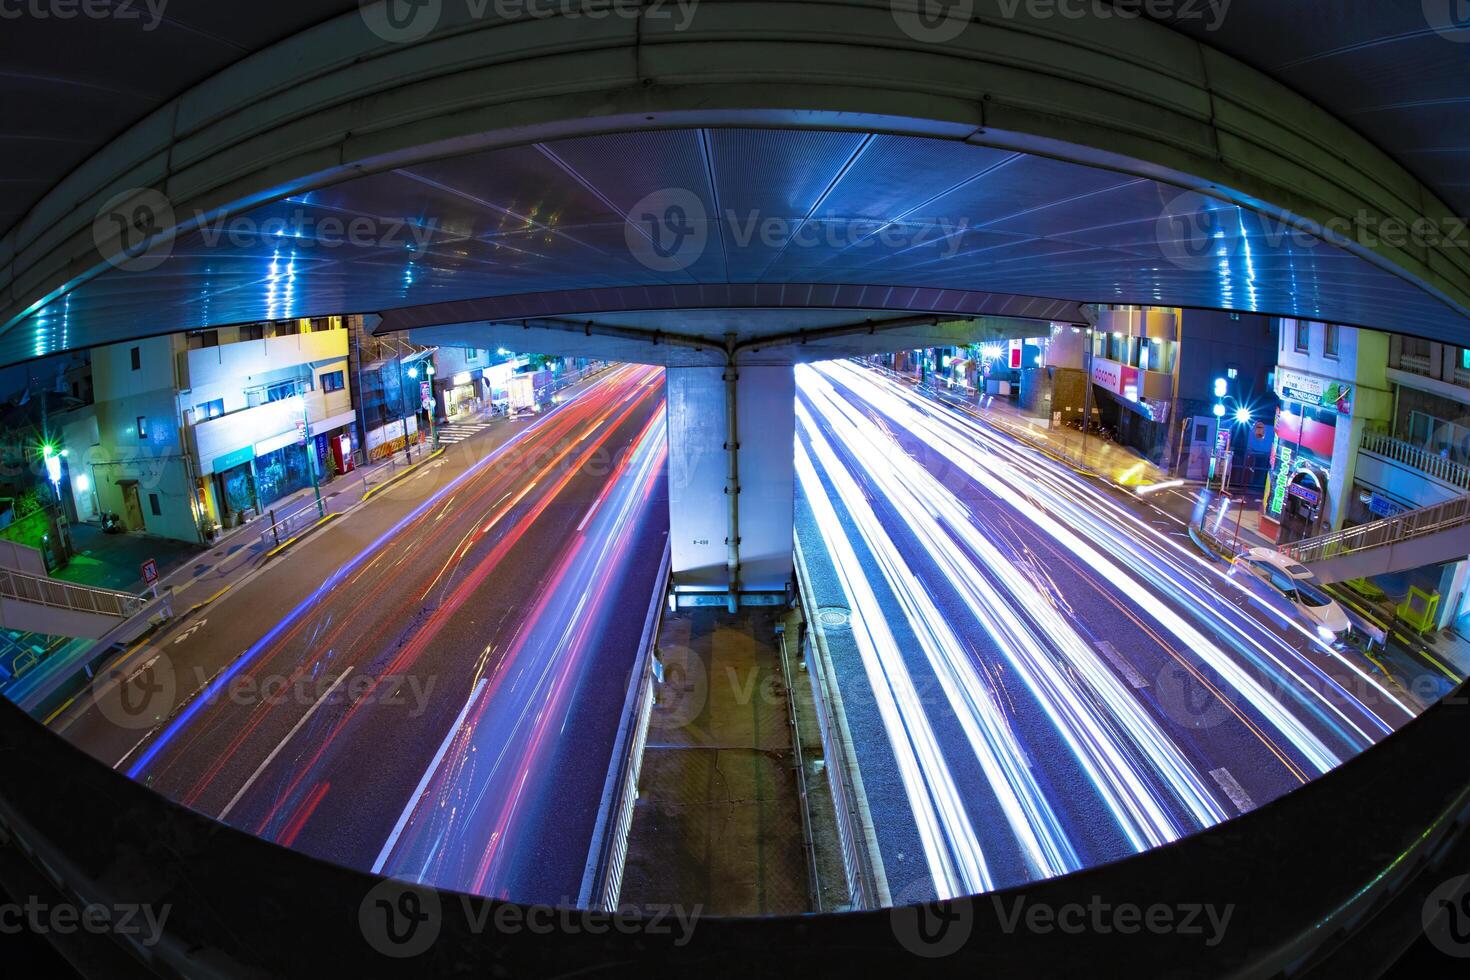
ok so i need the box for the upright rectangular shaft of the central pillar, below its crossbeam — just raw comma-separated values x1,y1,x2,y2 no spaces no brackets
666,363,797,597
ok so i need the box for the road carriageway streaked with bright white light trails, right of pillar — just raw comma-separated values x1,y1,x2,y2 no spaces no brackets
797,361,1411,901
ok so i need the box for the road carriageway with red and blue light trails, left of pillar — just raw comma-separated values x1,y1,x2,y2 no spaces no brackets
65,367,667,904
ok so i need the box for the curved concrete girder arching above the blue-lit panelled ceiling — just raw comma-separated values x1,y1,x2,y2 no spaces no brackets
0,0,1470,359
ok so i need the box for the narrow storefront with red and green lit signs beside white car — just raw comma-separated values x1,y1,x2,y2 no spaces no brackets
1261,367,1352,544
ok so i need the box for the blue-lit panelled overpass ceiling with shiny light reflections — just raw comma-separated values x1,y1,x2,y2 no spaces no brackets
0,129,1470,363
